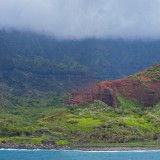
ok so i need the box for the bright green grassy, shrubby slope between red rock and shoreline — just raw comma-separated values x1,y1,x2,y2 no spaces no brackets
0,97,160,146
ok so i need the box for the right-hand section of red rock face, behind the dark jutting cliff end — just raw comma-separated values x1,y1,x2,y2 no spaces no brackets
100,78,160,106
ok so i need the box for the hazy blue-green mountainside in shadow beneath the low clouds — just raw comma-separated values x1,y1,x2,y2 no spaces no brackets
0,30,160,98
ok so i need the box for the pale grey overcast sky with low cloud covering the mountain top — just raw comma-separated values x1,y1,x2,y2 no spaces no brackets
0,0,160,39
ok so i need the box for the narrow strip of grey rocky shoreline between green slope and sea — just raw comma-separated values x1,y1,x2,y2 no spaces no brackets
0,144,160,151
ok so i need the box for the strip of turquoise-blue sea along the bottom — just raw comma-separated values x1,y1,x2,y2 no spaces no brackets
0,149,160,160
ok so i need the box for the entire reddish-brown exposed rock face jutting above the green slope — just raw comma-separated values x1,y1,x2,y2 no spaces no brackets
69,78,160,107
